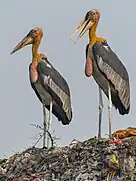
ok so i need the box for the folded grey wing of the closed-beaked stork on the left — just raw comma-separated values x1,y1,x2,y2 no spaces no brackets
38,59,72,121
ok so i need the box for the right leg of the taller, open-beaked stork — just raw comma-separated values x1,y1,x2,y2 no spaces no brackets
108,84,112,138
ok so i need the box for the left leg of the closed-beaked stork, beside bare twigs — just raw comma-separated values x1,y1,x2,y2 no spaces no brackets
43,104,47,148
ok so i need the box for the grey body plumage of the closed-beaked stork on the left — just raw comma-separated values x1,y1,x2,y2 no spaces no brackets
29,56,72,125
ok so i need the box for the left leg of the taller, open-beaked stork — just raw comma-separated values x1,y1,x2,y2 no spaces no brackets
98,87,103,138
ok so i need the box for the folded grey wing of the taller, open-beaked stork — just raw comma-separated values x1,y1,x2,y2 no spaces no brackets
93,42,130,110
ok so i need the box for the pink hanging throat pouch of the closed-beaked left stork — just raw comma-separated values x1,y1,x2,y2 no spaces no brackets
30,63,38,83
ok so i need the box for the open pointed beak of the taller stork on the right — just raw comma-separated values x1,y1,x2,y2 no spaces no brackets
70,20,94,43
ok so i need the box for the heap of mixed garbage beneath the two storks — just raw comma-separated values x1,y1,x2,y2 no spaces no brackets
0,137,136,181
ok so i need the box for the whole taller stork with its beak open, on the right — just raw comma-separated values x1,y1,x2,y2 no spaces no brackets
71,9,130,137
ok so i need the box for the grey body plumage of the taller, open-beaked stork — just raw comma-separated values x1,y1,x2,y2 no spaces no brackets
86,42,130,115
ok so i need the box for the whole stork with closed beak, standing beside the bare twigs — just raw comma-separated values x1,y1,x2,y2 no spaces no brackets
11,27,72,147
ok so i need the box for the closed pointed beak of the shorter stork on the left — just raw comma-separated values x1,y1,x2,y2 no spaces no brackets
10,35,33,54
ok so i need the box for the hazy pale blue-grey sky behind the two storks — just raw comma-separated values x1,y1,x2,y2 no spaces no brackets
0,0,136,157
